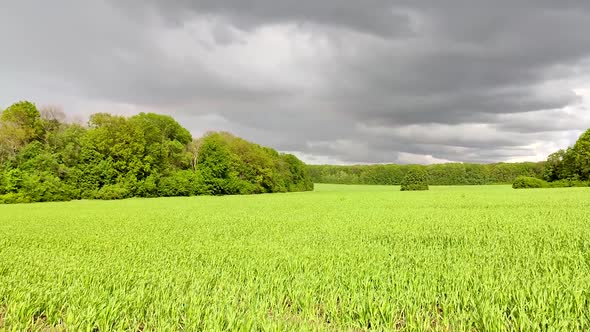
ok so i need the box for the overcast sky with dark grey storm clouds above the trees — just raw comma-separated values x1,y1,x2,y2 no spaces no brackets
0,0,590,164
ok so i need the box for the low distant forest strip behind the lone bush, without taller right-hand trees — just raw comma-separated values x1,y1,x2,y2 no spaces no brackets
308,163,544,185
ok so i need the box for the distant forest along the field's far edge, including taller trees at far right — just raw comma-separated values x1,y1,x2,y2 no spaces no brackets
308,129,590,187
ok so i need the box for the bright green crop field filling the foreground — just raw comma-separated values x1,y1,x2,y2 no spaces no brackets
0,185,590,331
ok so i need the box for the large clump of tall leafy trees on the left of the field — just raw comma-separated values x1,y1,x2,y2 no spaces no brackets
0,101,313,203
